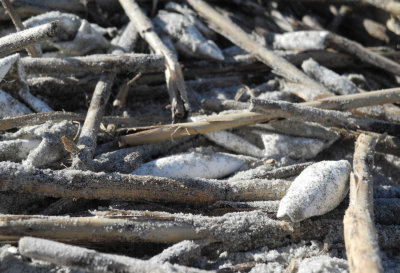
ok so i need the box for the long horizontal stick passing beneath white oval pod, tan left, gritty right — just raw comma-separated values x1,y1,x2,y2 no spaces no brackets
0,210,400,251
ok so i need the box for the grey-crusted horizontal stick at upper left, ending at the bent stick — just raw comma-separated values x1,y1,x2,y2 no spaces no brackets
21,54,164,75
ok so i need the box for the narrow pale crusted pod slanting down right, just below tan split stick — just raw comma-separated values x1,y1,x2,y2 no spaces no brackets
204,130,264,157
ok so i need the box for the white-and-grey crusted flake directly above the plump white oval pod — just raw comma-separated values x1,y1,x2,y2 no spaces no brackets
260,132,325,159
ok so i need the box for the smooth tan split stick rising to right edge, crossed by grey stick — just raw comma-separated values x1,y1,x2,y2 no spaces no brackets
119,88,400,146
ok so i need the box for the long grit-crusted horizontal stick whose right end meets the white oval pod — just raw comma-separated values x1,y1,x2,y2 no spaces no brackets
0,162,291,203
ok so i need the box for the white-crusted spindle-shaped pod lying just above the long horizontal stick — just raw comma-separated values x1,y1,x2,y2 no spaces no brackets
132,152,246,178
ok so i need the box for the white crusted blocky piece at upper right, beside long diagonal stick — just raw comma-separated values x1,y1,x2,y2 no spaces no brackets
273,31,328,51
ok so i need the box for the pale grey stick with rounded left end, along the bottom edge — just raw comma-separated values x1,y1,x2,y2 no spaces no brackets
18,237,212,273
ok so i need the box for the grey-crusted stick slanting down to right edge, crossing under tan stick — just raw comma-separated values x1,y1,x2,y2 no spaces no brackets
251,99,400,136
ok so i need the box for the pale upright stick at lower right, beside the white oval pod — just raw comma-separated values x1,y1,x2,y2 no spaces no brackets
343,134,383,273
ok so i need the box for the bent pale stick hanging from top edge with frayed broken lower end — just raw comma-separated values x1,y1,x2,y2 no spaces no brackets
119,0,190,118
